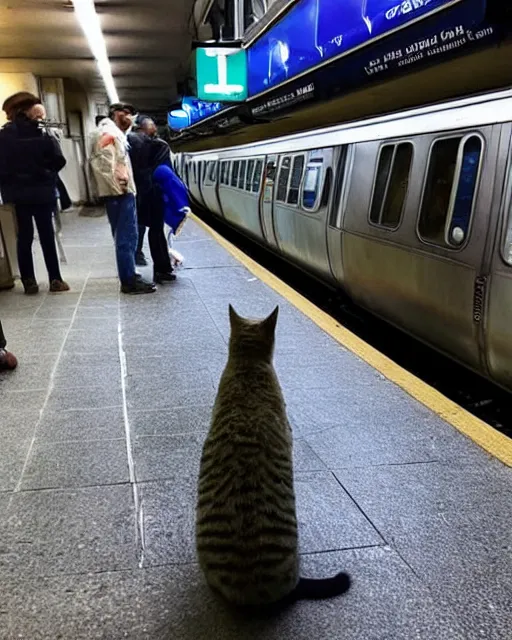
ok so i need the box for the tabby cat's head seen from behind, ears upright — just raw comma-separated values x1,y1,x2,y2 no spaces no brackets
229,305,279,359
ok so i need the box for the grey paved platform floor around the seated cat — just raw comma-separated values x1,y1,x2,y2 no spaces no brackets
0,214,512,640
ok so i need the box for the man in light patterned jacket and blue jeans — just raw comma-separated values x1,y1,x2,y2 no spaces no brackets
91,103,156,294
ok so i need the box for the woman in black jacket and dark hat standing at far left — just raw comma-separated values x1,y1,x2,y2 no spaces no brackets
0,96,69,294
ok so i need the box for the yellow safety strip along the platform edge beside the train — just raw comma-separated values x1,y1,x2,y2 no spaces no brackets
191,215,512,467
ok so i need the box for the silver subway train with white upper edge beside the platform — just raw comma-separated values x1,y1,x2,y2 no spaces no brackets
174,89,512,391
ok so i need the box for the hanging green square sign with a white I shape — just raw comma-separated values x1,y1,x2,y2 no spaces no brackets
196,47,247,102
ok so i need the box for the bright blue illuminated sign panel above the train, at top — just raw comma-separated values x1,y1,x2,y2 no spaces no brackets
248,0,485,96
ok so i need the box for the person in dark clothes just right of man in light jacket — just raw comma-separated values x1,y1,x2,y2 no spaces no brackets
128,116,176,284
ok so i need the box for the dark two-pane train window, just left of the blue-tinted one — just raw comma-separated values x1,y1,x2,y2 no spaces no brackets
370,142,413,229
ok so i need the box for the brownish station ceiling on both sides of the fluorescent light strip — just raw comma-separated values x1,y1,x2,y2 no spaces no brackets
0,0,193,117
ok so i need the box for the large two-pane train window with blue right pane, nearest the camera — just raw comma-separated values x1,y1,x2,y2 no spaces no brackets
418,134,483,248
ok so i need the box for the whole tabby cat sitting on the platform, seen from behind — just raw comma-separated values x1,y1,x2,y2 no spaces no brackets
196,305,350,606
